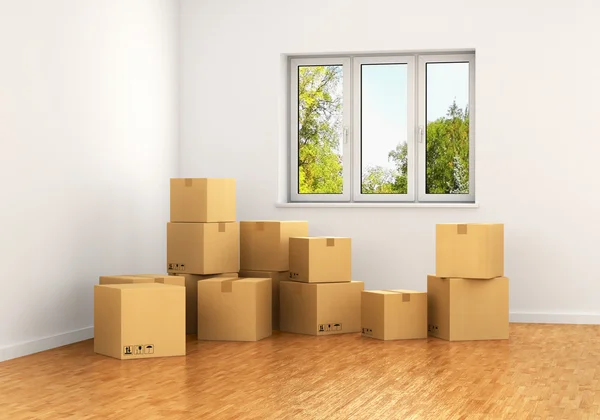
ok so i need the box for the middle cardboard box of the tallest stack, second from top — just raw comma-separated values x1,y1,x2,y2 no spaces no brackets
167,222,240,274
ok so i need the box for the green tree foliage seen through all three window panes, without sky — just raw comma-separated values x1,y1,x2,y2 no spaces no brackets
298,66,469,194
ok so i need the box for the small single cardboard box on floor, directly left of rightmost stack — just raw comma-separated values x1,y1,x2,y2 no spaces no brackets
361,290,427,340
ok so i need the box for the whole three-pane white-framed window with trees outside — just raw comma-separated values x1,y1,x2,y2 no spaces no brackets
290,53,475,202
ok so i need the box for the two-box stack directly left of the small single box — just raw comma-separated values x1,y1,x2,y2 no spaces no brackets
280,236,364,335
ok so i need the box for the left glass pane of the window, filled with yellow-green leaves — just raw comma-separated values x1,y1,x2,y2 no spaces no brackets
298,65,344,194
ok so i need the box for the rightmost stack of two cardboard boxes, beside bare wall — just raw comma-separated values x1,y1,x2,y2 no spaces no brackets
427,223,509,341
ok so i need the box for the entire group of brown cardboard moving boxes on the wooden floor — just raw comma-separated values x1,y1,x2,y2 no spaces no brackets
94,178,509,359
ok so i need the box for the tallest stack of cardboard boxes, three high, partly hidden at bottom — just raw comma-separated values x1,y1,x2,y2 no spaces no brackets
167,178,240,336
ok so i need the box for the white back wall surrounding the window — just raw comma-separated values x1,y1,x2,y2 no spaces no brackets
180,0,600,323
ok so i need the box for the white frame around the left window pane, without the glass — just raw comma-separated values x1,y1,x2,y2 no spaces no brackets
290,57,352,202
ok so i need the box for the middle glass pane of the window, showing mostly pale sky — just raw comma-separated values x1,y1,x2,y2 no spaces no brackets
360,64,408,194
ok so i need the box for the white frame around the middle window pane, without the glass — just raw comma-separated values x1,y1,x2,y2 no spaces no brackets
352,56,415,202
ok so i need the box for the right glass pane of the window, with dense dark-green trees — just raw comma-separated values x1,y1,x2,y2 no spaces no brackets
425,63,469,194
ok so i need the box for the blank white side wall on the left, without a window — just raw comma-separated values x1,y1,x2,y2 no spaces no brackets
0,0,178,361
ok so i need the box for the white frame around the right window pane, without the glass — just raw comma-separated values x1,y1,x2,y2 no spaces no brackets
417,54,475,203
